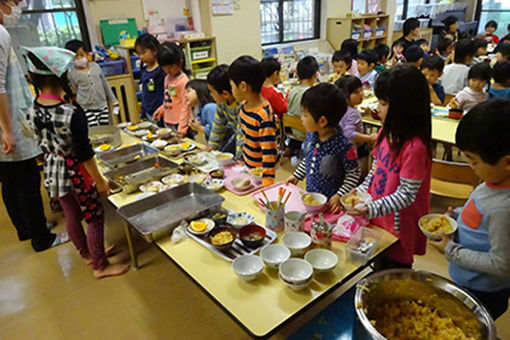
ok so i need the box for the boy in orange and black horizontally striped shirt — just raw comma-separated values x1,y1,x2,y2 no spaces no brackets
228,56,277,186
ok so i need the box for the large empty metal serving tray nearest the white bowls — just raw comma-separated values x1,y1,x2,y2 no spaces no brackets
117,183,225,242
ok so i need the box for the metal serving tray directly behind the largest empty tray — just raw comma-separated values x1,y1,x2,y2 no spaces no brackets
104,156,178,194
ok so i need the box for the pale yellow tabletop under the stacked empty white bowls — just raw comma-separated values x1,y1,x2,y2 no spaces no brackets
104,130,397,337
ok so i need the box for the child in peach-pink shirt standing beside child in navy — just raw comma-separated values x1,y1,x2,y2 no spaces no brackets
153,41,190,138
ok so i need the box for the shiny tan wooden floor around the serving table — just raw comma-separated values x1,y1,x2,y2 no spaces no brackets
0,160,510,340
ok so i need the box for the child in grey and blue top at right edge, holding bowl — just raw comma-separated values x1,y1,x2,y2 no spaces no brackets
432,100,510,320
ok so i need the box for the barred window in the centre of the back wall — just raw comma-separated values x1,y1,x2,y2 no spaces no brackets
260,0,320,45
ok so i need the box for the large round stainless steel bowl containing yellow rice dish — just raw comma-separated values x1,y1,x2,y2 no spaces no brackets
354,269,496,340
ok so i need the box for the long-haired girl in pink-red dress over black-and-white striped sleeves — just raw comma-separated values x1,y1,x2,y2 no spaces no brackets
350,64,432,271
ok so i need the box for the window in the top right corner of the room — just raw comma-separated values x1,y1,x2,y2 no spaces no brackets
477,0,510,37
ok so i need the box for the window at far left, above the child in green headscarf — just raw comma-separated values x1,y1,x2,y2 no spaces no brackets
8,0,90,47
